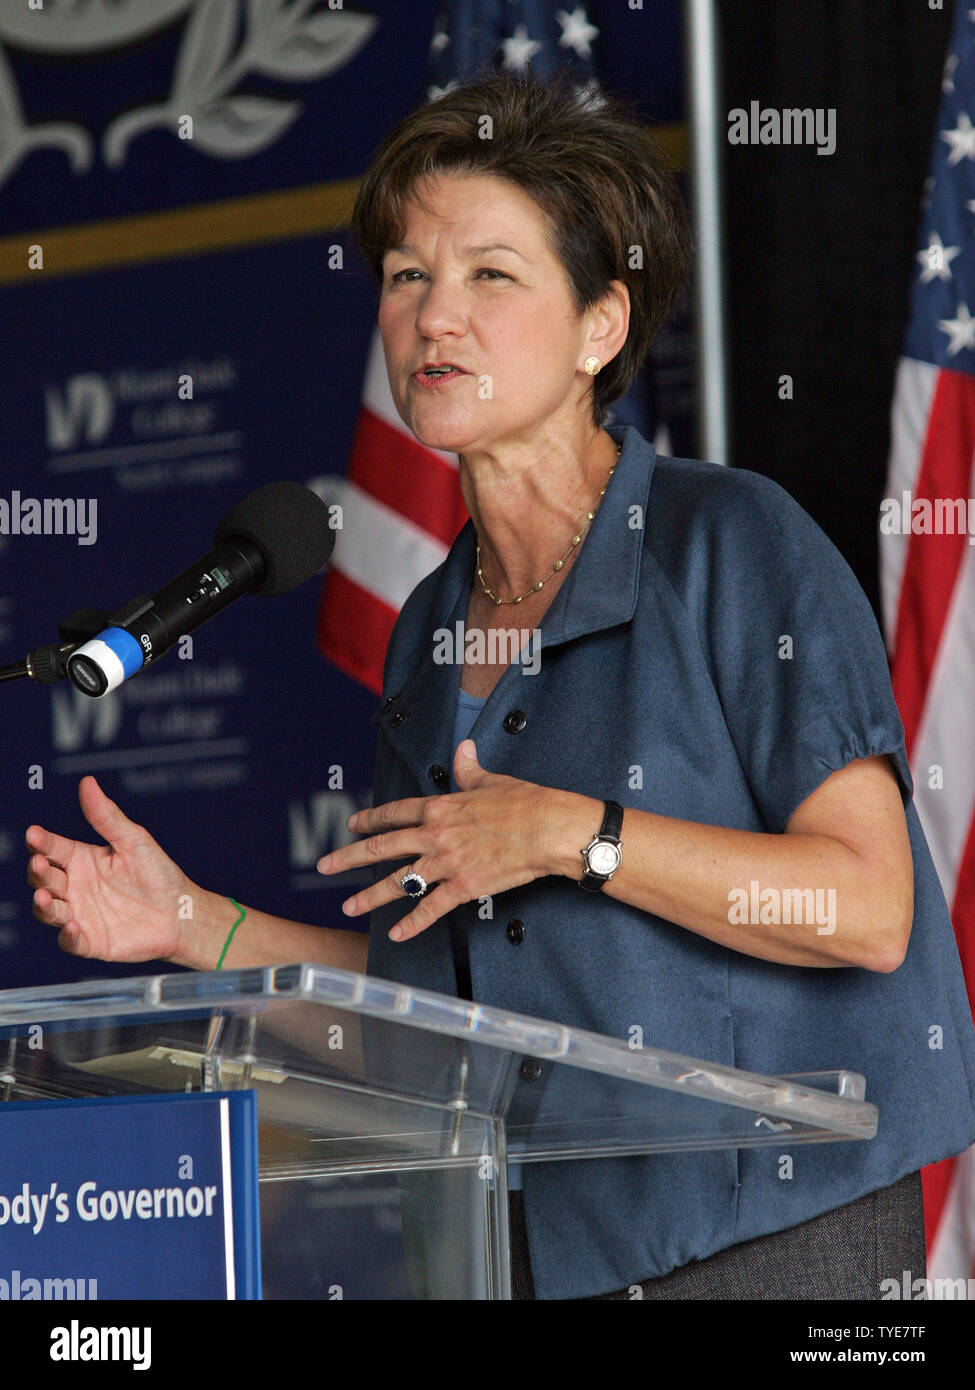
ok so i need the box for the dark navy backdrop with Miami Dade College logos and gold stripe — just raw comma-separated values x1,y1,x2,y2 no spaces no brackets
0,0,690,988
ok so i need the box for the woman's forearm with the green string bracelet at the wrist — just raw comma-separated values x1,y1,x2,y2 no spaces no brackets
170,890,369,973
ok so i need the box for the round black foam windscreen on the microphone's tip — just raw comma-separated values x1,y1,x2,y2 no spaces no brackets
214,481,335,595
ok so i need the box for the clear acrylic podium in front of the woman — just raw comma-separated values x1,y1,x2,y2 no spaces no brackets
0,965,878,1300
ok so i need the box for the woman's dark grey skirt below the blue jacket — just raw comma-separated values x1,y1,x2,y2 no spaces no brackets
508,1173,926,1300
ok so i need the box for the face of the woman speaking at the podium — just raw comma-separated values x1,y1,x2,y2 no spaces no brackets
378,174,590,453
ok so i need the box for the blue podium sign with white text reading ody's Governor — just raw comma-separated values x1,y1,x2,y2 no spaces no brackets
0,1091,260,1301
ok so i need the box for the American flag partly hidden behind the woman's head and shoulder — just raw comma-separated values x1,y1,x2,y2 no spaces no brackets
317,0,644,694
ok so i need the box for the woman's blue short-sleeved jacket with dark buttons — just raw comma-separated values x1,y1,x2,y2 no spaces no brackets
369,427,975,1298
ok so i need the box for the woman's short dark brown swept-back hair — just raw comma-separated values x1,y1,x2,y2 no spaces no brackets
352,68,691,427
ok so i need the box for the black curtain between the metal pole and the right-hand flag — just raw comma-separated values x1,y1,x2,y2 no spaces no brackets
719,0,953,613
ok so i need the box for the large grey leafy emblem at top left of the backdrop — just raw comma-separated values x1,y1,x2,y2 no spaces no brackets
0,0,378,183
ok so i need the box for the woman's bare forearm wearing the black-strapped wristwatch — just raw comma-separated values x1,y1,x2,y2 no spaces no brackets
548,791,903,970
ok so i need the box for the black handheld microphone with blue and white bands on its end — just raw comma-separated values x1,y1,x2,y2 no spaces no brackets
67,482,335,698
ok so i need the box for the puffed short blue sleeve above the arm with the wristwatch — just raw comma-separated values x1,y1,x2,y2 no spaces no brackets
675,470,914,833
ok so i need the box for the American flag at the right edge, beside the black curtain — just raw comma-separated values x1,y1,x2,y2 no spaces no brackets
880,4,975,1280
